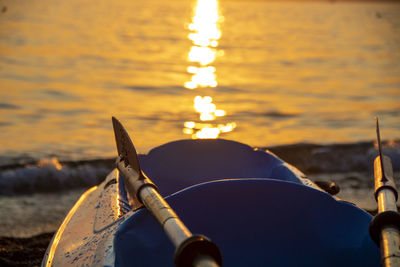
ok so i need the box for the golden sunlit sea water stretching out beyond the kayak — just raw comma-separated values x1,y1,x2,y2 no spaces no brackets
0,0,400,238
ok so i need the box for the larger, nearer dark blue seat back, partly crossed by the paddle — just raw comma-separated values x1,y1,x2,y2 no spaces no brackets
114,178,380,267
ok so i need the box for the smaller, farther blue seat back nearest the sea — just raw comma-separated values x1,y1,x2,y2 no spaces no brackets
139,139,304,196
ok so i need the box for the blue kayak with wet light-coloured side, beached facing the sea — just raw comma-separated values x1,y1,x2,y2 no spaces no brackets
42,119,381,266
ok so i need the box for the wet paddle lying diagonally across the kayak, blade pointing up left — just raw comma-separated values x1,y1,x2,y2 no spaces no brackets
112,117,222,267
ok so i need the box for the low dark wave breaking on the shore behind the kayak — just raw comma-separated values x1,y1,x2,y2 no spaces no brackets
0,140,400,195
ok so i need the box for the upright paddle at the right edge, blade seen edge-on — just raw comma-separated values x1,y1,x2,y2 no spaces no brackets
369,117,400,267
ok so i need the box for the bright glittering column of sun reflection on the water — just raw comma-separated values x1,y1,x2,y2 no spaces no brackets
183,0,236,138
